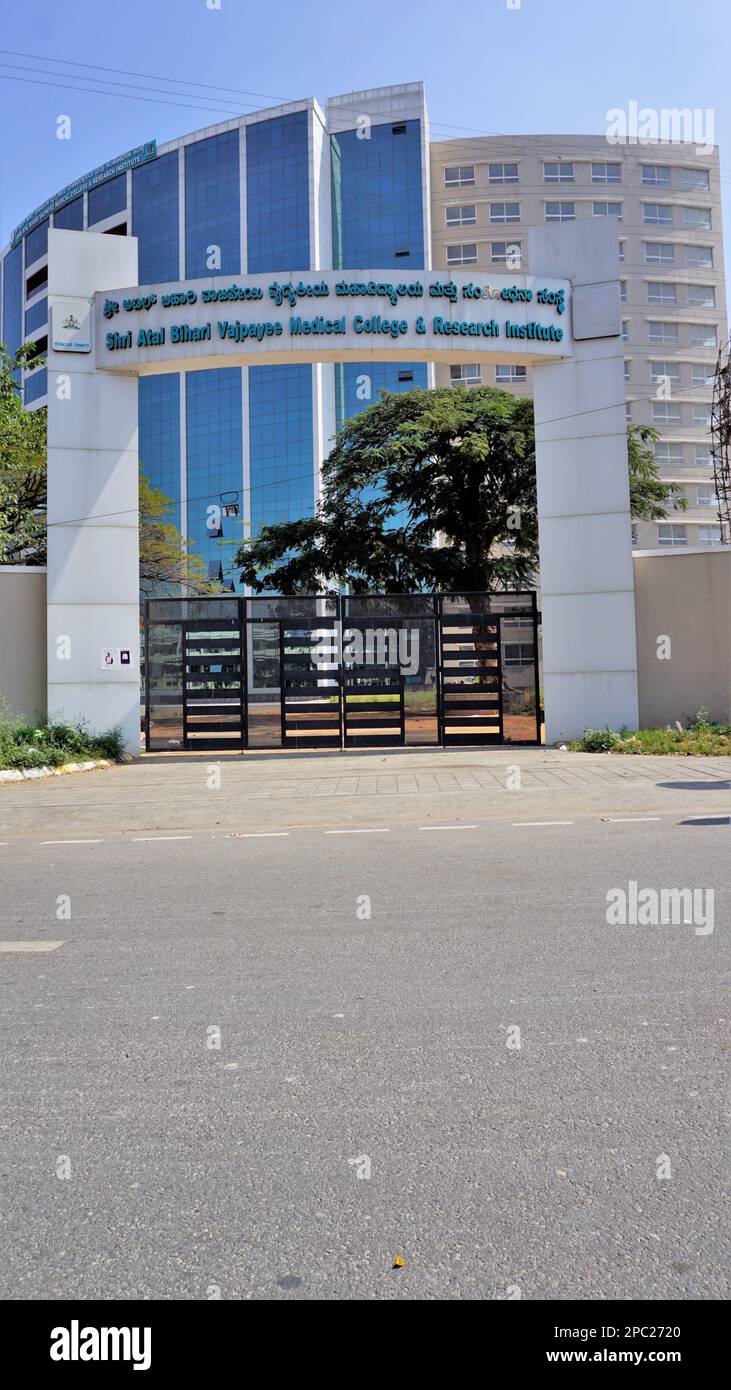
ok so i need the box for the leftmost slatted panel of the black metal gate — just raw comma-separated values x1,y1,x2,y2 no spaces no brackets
182,619,246,752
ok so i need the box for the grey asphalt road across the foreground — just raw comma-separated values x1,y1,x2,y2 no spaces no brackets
0,774,731,1300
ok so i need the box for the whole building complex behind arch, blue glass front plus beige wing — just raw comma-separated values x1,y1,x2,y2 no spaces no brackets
0,83,725,582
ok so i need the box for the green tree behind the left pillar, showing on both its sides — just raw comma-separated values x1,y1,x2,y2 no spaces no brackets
0,343,220,598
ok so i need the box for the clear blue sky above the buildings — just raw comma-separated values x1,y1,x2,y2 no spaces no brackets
0,0,731,258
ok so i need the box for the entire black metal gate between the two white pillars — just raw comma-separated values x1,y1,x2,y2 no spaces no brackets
143,592,542,752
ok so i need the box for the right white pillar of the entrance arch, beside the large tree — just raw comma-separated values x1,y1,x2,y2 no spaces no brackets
528,217,639,744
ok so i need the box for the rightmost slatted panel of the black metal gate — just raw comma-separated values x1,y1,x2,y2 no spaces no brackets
441,613,503,746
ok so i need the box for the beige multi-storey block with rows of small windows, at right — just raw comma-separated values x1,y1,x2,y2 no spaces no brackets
429,135,727,549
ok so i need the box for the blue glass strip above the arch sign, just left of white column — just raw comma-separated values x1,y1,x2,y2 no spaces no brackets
246,111,310,275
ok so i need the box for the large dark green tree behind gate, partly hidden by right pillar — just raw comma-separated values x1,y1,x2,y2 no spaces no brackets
238,386,673,594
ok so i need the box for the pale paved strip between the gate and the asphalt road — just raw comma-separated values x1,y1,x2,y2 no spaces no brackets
0,748,731,842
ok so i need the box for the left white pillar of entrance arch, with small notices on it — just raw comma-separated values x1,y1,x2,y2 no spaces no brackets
47,228,140,753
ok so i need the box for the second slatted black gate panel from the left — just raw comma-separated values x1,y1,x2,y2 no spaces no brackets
279,623,342,748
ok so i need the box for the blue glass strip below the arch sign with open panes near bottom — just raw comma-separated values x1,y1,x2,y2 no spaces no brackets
185,367,243,584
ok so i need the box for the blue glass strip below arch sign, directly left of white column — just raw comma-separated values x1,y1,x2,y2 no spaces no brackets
249,364,314,537
